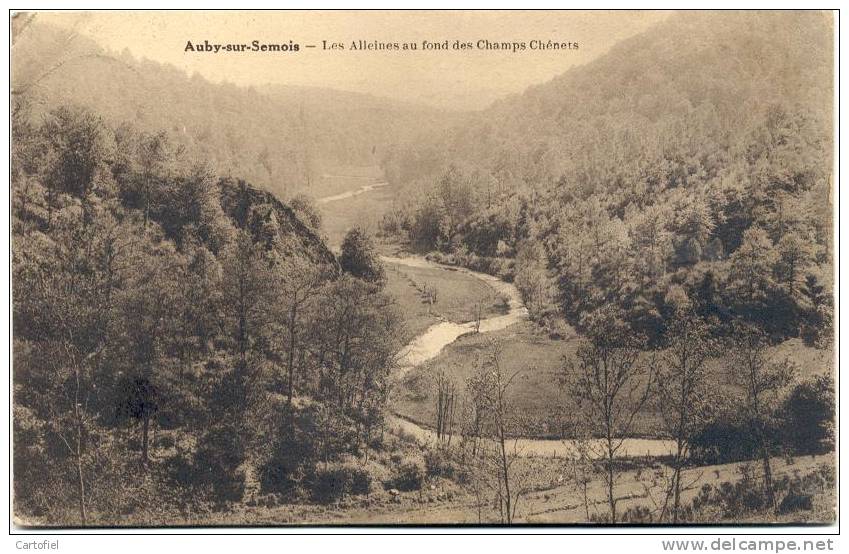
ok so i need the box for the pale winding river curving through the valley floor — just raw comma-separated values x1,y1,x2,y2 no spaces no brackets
318,178,675,457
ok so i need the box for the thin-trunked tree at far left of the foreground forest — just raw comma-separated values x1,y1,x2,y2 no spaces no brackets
15,206,114,525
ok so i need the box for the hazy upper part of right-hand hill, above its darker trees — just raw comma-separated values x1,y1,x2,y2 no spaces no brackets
386,12,833,196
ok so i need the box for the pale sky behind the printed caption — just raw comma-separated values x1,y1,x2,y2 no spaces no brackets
29,11,669,109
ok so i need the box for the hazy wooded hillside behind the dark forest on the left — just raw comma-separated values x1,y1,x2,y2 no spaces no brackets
12,19,452,198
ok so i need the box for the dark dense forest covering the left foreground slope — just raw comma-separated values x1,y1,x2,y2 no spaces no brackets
12,98,400,524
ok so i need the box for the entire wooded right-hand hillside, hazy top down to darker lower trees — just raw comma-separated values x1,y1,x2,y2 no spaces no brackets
384,12,833,344
